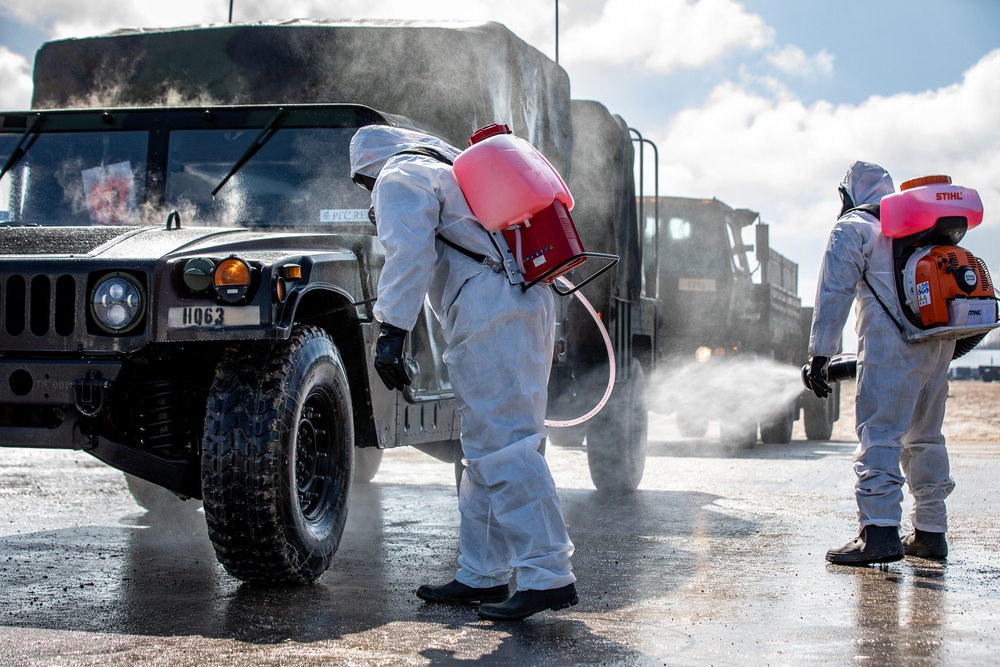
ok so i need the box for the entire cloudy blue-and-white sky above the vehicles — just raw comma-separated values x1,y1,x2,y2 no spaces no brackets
0,0,1000,350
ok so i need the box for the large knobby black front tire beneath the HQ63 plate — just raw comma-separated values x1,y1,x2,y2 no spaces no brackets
201,326,354,584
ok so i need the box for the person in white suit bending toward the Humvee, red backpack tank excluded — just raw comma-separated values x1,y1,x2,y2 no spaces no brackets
351,125,578,620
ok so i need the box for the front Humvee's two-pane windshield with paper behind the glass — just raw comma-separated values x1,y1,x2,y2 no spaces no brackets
0,127,370,229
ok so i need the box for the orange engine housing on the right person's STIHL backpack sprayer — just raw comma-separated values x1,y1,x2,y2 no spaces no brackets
903,245,995,327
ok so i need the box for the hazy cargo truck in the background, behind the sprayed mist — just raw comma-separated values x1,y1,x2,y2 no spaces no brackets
641,197,840,447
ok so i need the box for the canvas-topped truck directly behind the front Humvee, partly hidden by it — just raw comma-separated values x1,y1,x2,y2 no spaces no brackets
549,100,657,491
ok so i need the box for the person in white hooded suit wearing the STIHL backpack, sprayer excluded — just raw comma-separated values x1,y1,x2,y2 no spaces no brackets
807,162,955,565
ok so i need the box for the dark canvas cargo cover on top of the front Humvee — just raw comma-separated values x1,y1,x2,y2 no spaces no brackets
32,20,572,176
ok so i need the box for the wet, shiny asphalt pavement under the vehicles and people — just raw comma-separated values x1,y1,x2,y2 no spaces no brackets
0,415,1000,667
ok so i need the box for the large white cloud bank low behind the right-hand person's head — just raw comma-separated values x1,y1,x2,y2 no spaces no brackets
646,50,1000,324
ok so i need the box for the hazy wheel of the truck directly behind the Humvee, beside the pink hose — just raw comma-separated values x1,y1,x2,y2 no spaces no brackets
587,359,649,493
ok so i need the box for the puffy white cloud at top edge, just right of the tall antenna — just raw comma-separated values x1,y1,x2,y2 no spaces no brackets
561,0,774,74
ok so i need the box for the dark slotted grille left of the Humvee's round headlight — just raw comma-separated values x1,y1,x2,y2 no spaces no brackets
0,274,77,342
